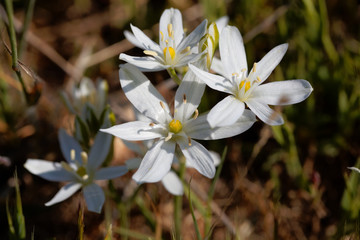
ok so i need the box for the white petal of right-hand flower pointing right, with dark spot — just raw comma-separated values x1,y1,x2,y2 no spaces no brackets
251,79,313,105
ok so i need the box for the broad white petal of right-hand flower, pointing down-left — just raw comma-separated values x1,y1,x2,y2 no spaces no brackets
207,96,245,127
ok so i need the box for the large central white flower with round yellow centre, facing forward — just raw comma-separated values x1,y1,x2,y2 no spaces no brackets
101,64,255,183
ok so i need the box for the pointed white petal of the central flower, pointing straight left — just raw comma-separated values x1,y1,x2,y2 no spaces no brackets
100,121,163,141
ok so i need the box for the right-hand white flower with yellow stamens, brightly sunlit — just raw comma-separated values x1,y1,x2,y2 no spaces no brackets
190,26,313,126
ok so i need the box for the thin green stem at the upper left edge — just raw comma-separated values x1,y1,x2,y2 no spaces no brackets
5,0,29,102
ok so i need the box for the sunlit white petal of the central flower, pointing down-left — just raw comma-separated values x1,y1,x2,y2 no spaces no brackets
133,140,175,183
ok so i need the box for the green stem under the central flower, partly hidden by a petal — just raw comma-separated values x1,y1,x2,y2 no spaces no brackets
174,147,186,240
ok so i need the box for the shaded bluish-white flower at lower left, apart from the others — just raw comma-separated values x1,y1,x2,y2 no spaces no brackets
24,129,128,213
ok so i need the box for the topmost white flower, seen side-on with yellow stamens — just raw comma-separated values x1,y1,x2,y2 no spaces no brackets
120,8,207,71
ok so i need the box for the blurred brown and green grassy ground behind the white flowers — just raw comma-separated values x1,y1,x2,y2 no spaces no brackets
0,0,360,239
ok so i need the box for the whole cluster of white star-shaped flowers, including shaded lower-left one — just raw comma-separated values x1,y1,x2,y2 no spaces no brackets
25,8,312,212
